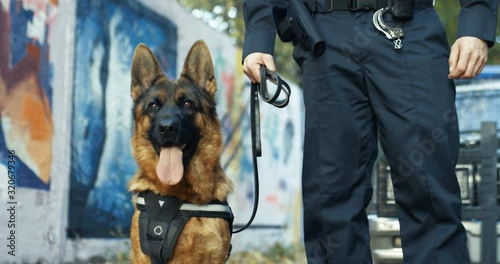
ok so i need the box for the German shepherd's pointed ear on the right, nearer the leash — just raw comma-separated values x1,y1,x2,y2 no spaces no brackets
181,40,217,96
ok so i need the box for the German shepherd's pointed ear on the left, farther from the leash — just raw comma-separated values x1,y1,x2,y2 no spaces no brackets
130,43,164,101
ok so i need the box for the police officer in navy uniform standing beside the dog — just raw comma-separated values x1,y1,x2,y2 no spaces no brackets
243,0,498,264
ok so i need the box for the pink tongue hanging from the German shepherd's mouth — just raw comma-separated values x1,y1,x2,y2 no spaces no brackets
156,147,184,185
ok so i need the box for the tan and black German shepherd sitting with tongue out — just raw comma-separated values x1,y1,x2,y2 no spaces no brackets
129,40,233,263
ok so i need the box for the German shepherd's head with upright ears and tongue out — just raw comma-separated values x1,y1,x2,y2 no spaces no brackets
131,41,221,185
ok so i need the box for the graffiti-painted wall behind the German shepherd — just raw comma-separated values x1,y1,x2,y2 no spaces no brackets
0,0,303,263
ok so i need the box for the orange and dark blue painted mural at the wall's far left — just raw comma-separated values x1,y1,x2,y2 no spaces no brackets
0,1,57,189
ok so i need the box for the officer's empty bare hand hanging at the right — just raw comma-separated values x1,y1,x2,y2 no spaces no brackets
448,37,488,79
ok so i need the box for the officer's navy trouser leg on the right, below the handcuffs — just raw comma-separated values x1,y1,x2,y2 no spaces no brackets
366,8,469,263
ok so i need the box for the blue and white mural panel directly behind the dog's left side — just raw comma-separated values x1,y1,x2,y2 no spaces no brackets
68,0,177,237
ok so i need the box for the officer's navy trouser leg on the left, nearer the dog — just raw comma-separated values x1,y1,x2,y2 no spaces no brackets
294,12,377,264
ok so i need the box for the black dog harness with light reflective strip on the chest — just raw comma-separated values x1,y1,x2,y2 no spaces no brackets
136,191,234,264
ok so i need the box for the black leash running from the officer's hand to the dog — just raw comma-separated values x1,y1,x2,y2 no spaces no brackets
233,66,291,234
